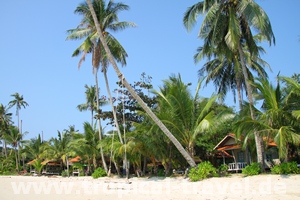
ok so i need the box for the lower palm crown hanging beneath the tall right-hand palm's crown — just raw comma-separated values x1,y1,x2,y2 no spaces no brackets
194,40,270,110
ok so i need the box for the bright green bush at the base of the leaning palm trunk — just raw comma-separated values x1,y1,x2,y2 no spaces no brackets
188,161,218,182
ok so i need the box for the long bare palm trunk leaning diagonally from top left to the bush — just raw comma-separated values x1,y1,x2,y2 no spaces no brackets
87,0,196,167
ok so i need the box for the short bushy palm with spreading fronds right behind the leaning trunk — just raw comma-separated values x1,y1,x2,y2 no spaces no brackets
155,75,233,157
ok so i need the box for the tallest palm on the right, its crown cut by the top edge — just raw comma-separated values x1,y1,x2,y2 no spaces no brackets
183,0,275,169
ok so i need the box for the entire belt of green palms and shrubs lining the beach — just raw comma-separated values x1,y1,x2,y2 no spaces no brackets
0,0,300,181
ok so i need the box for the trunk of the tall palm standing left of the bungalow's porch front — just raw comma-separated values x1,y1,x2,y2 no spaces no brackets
238,45,265,171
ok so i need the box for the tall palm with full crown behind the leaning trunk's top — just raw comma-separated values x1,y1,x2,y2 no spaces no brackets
67,0,135,172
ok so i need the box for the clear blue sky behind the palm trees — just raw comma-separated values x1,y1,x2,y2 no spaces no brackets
0,0,300,139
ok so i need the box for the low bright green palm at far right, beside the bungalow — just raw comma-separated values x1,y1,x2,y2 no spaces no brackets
237,78,300,161
